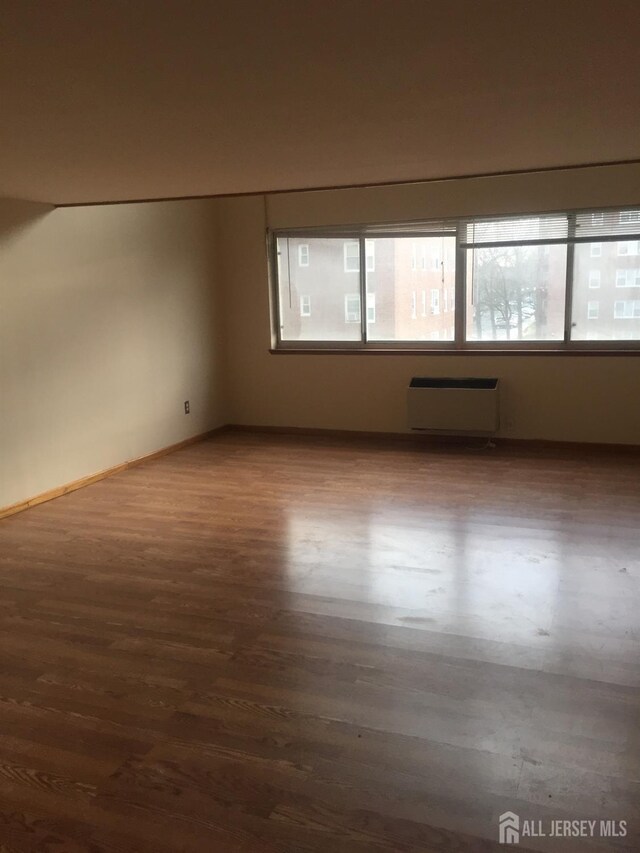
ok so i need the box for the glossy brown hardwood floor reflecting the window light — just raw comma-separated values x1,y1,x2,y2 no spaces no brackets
0,433,640,853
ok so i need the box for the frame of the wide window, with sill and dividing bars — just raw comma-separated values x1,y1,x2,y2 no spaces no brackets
267,210,640,356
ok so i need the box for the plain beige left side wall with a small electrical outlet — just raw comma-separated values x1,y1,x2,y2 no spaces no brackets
0,200,226,507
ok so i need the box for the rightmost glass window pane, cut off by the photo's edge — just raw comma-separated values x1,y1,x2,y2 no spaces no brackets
571,240,640,341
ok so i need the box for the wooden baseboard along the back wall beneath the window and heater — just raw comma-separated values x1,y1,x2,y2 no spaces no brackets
226,424,640,456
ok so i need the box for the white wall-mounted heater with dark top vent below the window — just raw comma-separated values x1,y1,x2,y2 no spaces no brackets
407,376,500,435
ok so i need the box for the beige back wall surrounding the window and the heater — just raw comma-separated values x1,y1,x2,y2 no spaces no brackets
220,165,640,444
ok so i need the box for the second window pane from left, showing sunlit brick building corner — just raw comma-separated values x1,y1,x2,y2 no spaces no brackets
367,236,456,341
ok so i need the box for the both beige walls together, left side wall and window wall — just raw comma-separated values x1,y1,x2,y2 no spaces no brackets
0,166,640,507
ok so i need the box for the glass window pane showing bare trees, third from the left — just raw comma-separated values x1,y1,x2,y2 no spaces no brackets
467,245,567,341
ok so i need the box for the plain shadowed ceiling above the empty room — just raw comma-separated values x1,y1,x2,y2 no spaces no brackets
0,0,640,204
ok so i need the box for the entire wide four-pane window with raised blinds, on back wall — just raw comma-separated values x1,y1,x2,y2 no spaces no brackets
270,209,640,351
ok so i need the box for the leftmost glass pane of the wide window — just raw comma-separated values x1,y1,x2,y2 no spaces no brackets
277,237,361,341
